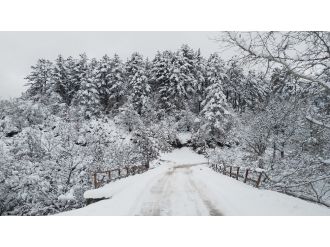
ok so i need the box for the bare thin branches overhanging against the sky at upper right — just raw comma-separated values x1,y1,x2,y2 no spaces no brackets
216,31,330,128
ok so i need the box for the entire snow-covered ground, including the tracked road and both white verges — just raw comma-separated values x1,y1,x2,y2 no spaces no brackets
60,148,330,215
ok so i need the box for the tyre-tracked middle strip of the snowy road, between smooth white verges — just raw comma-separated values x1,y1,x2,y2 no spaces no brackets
134,165,222,215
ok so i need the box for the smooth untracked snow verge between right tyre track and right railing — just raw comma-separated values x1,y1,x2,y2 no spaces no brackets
193,167,330,215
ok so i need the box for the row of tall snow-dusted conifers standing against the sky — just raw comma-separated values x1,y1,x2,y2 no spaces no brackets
25,45,268,146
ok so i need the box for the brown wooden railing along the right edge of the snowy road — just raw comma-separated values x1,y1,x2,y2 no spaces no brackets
210,164,265,188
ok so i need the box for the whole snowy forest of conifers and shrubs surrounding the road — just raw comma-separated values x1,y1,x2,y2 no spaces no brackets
0,33,330,215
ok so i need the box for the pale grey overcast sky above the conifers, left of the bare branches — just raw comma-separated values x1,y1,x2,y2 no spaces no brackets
0,32,226,99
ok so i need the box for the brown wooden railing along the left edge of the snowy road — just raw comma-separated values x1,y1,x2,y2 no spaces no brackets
92,165,149,189
